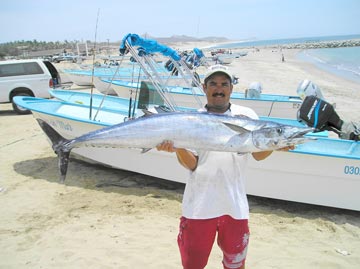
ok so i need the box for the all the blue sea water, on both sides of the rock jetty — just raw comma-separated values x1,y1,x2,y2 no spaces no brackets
208,35,360,83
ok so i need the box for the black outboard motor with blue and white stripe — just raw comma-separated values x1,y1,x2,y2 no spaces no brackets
298,95,360,141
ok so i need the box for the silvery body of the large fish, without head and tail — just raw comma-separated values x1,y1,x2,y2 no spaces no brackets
68,113,245,150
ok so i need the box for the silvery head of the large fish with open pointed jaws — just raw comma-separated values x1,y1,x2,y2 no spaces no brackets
251,125,314,151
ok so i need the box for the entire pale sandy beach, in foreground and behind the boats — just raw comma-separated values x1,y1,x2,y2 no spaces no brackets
0,44,360,269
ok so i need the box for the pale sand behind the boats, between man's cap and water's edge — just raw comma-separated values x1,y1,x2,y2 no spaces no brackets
232,46,360,122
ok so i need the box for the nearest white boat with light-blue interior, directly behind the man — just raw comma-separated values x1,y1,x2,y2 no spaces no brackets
15,96,360,211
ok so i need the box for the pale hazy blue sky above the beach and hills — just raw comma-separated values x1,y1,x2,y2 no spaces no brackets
0,0,360,43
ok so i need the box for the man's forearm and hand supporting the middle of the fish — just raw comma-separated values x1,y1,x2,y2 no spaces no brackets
156,141,198,171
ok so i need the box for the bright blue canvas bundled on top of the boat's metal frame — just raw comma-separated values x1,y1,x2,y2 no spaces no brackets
119,34,181,61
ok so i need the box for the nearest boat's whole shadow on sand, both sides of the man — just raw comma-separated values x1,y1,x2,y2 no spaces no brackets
14,154,360,227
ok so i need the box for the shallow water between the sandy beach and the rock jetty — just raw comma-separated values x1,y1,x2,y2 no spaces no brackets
298,47,360,83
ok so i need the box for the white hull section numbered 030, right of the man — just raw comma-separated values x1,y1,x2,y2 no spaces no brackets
246,152,360,211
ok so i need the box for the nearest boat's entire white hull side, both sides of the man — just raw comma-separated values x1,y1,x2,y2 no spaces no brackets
34,108,360,211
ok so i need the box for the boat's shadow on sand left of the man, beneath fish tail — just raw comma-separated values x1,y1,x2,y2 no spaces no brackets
14,157,185,200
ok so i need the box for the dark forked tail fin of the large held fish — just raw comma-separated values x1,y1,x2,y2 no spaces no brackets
37,119,70,183
